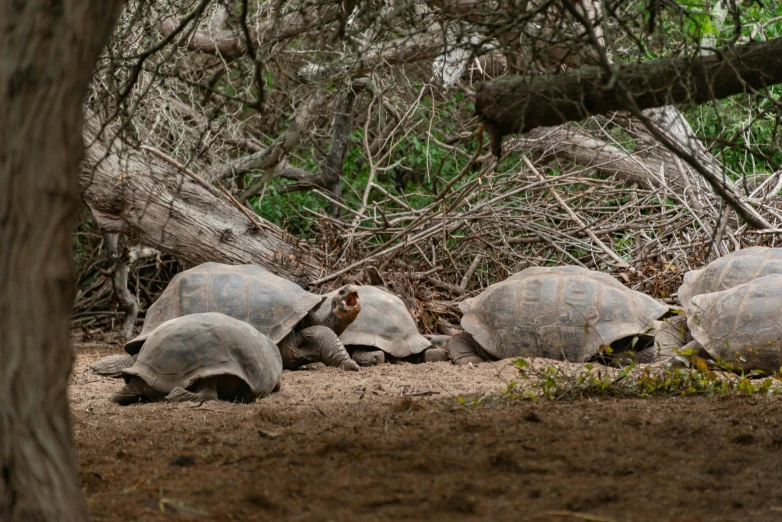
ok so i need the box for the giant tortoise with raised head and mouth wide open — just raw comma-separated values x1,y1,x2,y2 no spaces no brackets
92,263,361,376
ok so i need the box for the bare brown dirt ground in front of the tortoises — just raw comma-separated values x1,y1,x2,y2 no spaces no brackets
70,343,782,521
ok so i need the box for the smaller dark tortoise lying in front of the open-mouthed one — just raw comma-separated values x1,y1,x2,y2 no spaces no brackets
111,312,282,405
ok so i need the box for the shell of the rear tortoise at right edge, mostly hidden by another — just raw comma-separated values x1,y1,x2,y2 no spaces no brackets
679,247,782,310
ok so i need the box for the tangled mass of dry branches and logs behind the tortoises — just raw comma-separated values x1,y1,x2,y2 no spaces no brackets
74,0,782,332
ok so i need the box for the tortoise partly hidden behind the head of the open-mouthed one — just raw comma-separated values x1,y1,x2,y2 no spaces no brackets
326,285,447,366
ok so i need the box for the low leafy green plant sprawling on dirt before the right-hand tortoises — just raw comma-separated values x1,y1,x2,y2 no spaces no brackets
503,359,782,400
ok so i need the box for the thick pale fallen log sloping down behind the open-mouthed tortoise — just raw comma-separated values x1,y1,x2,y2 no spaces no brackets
79,119,320,281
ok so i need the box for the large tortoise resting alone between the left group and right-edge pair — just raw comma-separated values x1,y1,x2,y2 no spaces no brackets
448,266,670,364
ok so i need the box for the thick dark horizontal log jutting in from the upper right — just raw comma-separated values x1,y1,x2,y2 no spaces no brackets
475,34,782,137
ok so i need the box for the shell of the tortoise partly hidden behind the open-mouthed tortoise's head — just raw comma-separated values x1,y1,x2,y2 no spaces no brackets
326,286,432,358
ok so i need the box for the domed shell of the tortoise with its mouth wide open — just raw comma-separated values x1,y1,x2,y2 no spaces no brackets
125,263,324,355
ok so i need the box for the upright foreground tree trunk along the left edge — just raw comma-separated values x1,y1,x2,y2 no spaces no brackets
0,0,122,521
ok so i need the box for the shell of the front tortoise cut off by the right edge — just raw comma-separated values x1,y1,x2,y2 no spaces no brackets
687,274,782,374
